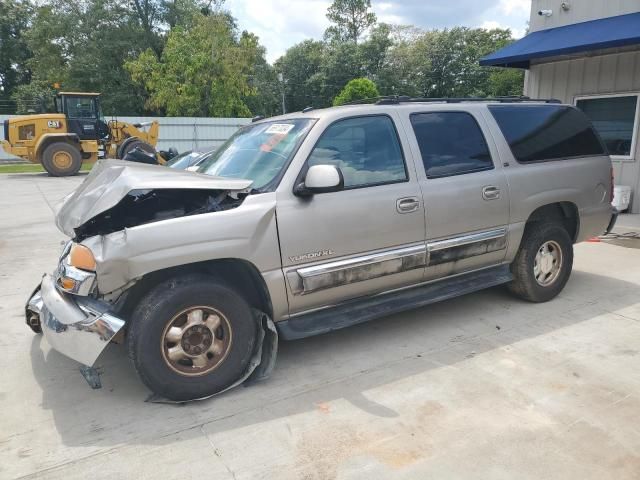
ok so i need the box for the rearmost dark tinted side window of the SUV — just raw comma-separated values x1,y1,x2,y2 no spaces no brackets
489,105,605,163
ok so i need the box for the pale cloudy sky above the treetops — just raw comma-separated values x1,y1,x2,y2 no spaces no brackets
225,0,531,62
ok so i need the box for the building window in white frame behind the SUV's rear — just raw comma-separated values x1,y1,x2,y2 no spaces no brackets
576,95,638,157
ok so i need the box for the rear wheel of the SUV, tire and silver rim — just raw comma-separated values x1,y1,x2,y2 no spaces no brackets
508,222,573,303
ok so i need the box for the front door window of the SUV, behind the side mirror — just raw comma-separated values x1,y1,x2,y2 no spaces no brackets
308,115,408,188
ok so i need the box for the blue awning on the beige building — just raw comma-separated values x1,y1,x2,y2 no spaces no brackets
480,12,640,68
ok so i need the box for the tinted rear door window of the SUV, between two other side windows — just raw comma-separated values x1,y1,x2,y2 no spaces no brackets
411,112,493,178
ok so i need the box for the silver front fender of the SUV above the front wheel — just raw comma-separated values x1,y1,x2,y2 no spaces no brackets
82,189,286,306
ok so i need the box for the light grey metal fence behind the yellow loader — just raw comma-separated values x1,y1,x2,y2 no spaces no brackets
0,115,251,162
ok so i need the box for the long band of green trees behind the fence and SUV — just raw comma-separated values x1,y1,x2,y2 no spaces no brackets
6,0,523,116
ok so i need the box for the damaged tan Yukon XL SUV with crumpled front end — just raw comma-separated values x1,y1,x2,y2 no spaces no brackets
26,98,615,401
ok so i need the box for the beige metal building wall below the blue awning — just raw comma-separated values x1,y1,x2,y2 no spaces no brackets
525,49,640,212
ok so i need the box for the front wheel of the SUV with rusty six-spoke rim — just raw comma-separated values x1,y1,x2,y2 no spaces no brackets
127,274,256,401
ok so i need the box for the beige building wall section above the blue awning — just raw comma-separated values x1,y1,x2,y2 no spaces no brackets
529,0,640,32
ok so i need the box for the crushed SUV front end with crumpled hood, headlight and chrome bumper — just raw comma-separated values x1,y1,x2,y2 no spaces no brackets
25,160,251,366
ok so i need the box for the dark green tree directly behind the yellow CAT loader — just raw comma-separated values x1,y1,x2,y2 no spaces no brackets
12,0,162,115
